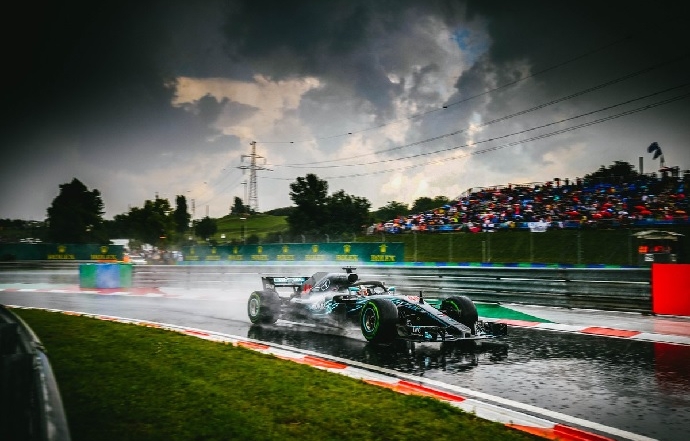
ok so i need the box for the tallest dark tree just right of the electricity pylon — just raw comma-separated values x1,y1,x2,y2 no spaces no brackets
287,173,329,234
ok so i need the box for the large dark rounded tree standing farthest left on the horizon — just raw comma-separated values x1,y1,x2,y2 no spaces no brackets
48,178,109,243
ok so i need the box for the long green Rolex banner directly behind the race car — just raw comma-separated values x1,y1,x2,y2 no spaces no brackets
182,242,405,263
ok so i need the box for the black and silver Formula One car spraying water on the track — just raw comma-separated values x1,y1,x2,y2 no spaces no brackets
247,267,508,343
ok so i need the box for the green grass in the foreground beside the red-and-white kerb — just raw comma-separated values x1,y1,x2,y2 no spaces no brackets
13,309,541,441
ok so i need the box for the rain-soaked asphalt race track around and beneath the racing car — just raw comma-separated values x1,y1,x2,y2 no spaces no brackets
0,266,690,441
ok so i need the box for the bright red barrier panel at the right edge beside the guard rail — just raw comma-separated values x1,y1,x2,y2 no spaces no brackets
652,263,690,316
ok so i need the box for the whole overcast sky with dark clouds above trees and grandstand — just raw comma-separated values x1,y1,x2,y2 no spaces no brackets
0,0,690,220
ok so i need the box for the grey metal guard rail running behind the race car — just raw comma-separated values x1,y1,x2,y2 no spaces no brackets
132,265,652,313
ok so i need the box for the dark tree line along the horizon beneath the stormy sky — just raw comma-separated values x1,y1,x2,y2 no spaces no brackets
0,161,672,248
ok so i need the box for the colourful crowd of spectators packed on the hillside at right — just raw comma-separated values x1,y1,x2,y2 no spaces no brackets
368,175,690,234
